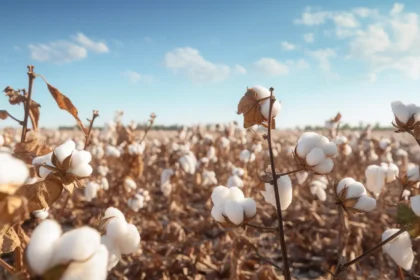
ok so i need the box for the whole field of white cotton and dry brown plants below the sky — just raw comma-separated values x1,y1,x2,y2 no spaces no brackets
0,66,420,280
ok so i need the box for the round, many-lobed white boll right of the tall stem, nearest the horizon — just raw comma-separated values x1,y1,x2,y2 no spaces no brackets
294,132,337,174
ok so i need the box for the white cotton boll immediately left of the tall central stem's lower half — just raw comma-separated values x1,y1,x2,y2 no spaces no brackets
211,186,257,226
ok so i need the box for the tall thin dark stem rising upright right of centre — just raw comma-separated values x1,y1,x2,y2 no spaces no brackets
267,88,292,280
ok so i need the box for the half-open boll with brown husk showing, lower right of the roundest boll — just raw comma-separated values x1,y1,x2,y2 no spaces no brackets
335,177,376,213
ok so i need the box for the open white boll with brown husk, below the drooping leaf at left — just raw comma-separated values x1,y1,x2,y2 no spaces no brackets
32,140,92,178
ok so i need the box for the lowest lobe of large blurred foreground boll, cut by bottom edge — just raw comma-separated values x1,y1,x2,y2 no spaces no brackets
60,245,108,280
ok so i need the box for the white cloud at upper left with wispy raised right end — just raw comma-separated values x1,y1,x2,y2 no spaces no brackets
28,33,109,64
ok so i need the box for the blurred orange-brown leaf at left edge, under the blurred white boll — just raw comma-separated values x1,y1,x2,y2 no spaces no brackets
0,195,29,226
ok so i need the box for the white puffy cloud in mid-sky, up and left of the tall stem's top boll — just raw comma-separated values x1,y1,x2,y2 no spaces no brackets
164,47,231,82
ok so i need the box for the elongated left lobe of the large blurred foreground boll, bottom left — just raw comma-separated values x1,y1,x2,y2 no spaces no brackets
26,220,62,275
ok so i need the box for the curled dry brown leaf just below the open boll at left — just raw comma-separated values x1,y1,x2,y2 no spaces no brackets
16,174,63,212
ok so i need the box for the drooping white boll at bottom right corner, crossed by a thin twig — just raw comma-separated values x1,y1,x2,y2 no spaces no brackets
382,228,414,271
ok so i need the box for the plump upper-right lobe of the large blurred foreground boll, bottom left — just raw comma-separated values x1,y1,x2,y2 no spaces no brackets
50,226,101,267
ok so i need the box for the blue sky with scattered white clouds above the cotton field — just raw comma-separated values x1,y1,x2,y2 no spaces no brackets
0,0,420,128
